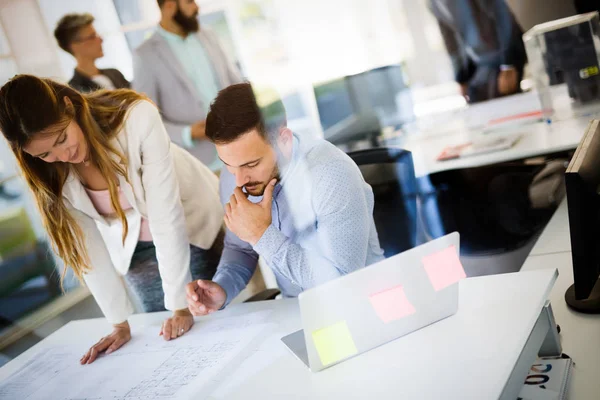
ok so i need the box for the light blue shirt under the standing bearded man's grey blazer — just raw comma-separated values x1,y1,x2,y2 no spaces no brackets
158,25,223,171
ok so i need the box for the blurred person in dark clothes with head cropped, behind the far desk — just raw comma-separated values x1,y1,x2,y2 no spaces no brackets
429,0,527,103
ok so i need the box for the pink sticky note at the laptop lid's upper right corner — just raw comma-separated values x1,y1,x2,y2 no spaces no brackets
422,246,467,292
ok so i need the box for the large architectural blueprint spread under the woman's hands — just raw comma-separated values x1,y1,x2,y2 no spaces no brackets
0,311,270,400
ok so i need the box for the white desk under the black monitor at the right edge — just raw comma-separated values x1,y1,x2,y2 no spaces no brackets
521,201,600,400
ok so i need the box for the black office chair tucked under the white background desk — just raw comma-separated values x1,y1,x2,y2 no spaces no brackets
432,162,554,257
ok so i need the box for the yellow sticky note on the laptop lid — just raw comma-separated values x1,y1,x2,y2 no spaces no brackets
312,321,358,366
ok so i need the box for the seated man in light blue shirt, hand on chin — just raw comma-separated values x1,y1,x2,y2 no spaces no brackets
187,83,383,315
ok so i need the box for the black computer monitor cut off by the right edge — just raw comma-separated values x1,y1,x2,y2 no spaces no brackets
565,120,600,314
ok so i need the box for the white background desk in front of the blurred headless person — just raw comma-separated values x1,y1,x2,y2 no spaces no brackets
384,92,600,176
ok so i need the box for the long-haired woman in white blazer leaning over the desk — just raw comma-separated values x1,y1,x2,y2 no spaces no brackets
0,75,223,364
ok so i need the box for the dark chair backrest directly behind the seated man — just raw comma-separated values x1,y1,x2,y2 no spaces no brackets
348,147,417,257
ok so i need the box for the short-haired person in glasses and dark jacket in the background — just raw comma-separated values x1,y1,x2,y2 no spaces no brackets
54,14,131,92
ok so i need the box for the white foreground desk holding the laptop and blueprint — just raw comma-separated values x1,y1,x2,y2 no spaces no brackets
0,270,554,400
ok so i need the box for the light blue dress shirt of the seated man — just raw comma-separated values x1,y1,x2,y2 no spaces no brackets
213,136,383,304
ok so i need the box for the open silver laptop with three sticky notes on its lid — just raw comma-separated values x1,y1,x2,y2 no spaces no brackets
281,232,466,372
